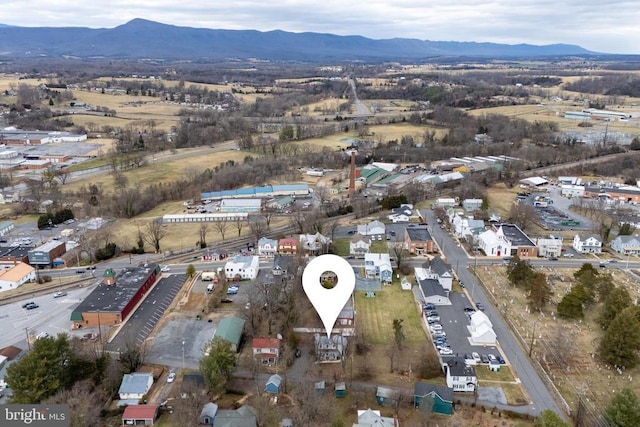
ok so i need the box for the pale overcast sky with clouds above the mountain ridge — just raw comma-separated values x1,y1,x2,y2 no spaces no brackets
0,0,640,54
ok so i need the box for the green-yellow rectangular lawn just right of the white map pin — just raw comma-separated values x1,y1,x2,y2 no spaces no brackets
355,284,426,345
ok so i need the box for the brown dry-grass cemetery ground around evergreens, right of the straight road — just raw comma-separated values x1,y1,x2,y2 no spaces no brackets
478,266,640,409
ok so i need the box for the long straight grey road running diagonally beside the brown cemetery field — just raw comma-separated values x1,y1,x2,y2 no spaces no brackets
424,210,565,415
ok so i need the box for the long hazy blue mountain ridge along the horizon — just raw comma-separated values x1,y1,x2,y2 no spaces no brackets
0,19,596,62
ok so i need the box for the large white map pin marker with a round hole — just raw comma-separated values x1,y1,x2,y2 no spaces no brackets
302,255,356,338
